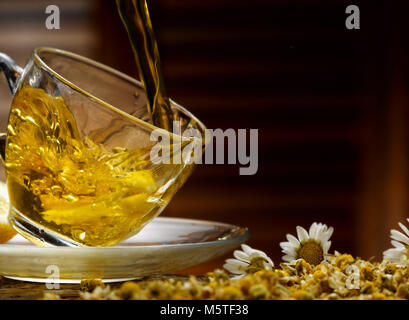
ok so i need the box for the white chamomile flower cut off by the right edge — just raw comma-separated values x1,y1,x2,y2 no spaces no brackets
383,219,409,266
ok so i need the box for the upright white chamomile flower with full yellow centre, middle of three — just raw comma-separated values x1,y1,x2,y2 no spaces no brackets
280,222,334,266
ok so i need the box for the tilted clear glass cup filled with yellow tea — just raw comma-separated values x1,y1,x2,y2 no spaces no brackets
0,48,206,246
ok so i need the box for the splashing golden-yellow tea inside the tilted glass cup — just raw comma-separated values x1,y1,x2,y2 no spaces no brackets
5,87,186,246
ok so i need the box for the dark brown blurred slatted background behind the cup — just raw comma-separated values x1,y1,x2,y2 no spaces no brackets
0,0,409,273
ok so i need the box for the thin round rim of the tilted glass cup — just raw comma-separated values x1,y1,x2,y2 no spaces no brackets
32,47,206,141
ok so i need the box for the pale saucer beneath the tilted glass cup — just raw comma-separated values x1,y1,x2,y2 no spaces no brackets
0,218,249,283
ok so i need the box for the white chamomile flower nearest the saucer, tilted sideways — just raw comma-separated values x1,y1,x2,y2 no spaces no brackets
223,244,274,275
